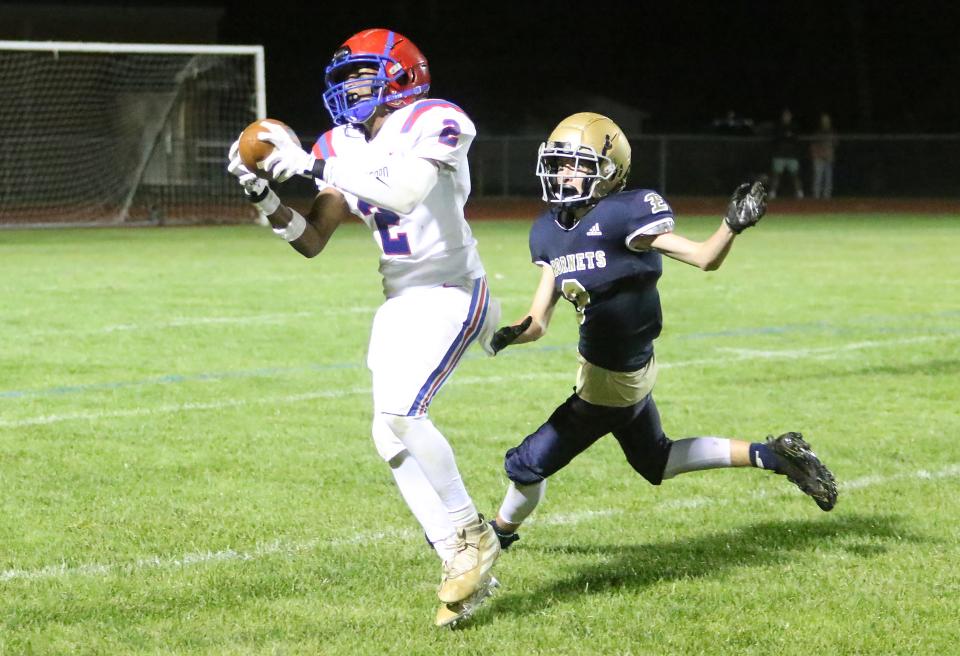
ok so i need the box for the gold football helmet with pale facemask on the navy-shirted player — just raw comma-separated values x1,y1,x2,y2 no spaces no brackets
537,112,630,208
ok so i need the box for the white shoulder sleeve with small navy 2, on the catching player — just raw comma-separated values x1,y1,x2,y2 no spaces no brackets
400,100,477,169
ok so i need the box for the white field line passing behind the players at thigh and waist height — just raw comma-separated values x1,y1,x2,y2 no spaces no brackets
0,335,960,428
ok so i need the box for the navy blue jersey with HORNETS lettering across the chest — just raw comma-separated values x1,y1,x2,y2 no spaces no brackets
530,189,674,371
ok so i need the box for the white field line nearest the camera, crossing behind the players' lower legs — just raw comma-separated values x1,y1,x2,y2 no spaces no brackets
0,463,960,583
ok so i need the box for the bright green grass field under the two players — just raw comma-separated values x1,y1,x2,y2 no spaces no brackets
0,213,960,655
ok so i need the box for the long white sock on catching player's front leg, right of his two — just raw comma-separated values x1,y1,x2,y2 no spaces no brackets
387,415,479,526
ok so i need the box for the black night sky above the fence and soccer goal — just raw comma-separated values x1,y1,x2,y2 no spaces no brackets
0,0,960,134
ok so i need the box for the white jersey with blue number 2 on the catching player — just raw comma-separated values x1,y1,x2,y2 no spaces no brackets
313,98,484,298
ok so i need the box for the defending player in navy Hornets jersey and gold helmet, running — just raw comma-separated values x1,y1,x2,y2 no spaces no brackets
491,112,837,547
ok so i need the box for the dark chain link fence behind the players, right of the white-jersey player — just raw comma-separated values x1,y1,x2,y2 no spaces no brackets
470,134,960,198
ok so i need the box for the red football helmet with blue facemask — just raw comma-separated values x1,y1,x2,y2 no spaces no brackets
323,28,430,125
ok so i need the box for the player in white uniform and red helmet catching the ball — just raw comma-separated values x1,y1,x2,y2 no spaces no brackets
222,29,500,626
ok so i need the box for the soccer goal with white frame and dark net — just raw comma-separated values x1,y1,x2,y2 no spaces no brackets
0,41,266,226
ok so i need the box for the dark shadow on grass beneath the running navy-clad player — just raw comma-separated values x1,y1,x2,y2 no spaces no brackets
484,515,929,623
